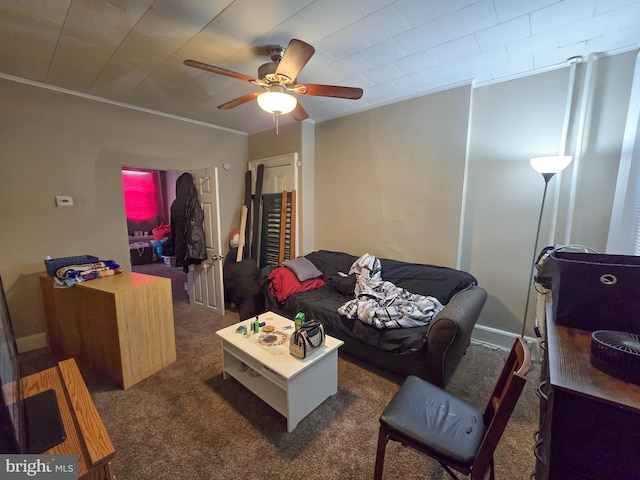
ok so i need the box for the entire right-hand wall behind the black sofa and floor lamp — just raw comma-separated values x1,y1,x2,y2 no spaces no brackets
314,52,636,344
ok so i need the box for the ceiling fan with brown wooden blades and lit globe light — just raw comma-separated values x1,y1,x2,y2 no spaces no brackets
184,38,363,121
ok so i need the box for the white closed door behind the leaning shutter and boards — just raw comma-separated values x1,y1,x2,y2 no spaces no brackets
249,153,300,258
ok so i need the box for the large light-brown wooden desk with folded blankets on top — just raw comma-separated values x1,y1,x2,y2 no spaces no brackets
40,272,176,389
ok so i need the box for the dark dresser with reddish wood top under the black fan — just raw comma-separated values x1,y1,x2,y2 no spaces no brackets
534,302,640,480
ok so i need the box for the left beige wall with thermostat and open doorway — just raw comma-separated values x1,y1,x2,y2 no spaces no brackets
0,80,248,337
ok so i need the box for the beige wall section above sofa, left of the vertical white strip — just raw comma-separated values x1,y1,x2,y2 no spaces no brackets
315,86,471,267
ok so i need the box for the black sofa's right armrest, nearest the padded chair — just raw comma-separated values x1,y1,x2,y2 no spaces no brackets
426,286,487,385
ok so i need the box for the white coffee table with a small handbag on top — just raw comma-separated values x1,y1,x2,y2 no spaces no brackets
216,312,344,432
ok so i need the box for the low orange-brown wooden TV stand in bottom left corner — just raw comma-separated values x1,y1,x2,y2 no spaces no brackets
22,359,116,480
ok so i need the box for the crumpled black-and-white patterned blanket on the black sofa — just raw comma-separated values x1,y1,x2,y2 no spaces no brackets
338,253,444,329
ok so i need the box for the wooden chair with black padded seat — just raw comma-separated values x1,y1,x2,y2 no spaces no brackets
374,338,531,480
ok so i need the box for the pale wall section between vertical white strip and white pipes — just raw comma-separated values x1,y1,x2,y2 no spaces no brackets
463,69,568,338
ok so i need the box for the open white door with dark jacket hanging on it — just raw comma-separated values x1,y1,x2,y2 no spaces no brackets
188,167,224,315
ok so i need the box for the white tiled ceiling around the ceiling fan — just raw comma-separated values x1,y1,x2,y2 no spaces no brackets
0,0,640,133
